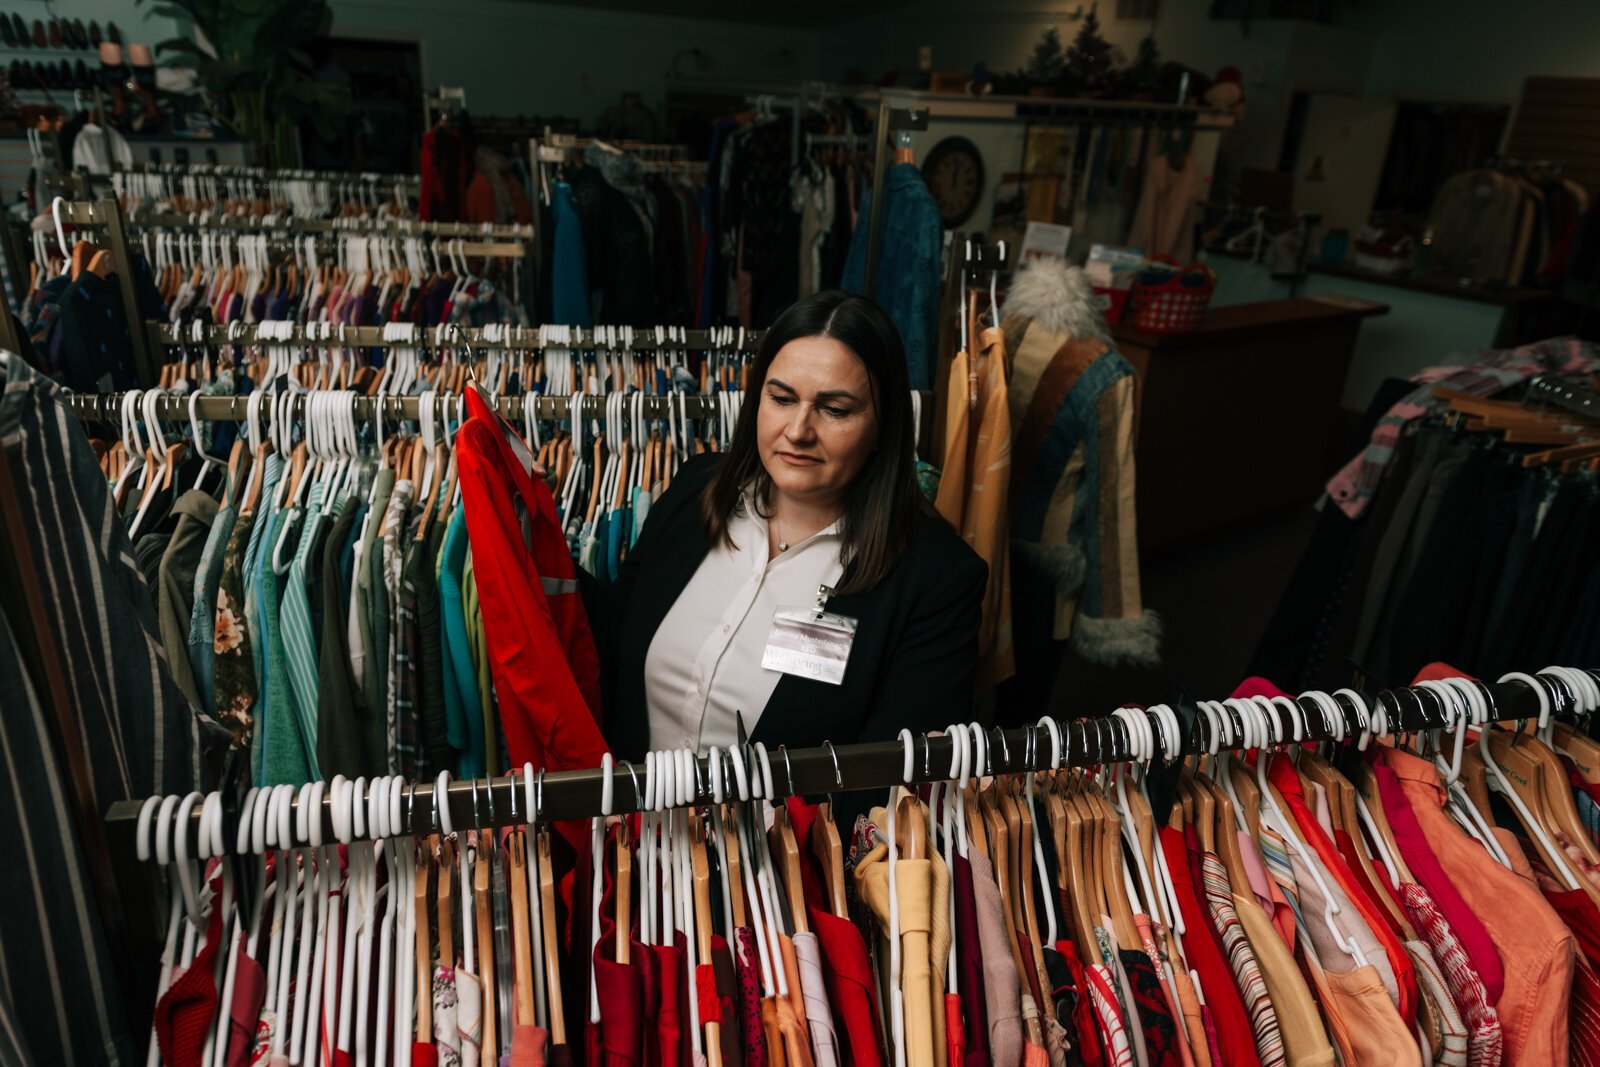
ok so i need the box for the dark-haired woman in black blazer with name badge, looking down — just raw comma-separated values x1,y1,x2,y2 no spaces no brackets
586,291,987,760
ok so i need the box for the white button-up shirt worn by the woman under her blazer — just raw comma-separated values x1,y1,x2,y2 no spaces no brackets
645,494,845,752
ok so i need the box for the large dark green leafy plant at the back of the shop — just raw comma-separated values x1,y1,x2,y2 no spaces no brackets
136,0,350,166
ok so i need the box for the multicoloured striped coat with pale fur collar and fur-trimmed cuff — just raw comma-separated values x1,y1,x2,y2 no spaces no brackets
1002,261,1160,665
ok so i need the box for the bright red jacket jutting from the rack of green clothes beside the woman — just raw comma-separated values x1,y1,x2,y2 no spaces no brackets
456,389,606,790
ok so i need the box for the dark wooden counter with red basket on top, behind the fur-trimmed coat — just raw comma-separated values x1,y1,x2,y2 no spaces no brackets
1112,296,1389,550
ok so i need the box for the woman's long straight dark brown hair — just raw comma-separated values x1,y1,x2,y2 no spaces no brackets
701,290,928,593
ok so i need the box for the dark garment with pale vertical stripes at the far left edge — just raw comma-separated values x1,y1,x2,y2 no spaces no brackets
0,352,229,1064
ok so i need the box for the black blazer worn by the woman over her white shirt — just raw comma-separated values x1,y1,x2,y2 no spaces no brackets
578,453,989,761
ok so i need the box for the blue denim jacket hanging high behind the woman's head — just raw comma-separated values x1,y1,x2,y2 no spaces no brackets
843,163,944,390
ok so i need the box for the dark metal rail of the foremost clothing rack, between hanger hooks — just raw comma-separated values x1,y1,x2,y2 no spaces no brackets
106,670,1600,854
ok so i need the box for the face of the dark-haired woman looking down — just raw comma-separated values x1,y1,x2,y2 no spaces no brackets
755,338,878,504
